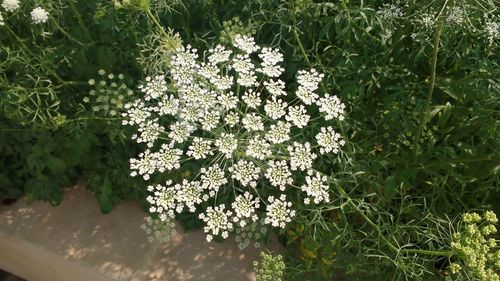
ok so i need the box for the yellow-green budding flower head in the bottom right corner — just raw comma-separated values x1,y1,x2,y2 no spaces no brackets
449,211,500,281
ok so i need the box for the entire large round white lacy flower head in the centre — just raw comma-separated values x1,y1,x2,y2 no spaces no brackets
122,35,345,241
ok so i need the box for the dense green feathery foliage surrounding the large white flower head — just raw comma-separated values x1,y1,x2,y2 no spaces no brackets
0,0,500,280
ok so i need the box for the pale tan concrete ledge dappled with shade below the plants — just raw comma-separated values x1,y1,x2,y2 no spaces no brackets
0,187,278,281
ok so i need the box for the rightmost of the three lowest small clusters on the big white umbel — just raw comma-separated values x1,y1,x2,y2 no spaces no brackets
264,194,295,228
